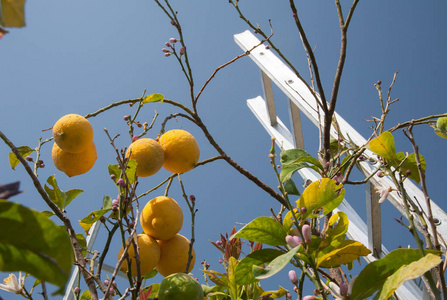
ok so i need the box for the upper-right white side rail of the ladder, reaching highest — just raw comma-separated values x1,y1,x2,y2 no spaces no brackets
234,30,447,247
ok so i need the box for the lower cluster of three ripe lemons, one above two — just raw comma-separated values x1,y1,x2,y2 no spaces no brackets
118,196,195,277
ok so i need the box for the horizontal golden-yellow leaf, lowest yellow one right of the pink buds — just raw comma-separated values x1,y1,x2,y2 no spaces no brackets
317,240,371,268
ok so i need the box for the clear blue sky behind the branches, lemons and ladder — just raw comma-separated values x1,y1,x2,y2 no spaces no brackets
0,0,447,299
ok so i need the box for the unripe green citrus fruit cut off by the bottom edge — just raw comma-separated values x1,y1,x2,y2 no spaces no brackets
158,273,204,300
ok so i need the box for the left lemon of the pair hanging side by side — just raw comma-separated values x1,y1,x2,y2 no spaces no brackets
126,138,164,177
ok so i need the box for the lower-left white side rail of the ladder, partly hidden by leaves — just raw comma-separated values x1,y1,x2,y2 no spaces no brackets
247,96,423,300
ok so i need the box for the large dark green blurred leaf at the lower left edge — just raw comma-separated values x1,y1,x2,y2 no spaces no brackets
0,200,73,293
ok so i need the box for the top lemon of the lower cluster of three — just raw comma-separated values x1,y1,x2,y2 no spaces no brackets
140,196,183,240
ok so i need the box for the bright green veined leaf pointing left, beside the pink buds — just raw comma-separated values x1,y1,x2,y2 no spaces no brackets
230,217,287,246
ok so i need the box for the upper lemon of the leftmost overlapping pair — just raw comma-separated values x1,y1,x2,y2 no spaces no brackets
53,114,93,153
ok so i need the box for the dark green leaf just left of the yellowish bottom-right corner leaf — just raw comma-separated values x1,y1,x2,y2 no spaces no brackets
350,248,439,300
